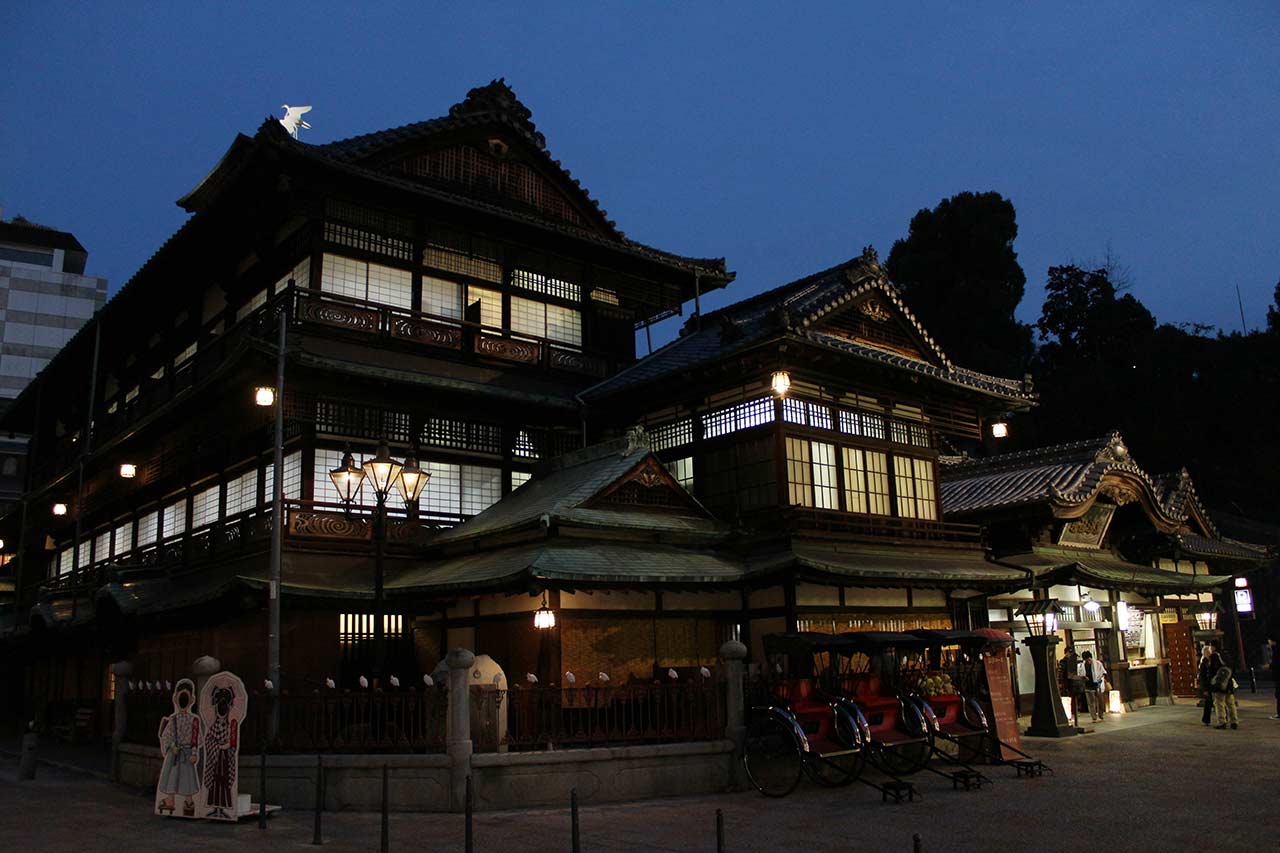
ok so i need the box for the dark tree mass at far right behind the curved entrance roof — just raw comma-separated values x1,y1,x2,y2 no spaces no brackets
1006,266,1280,521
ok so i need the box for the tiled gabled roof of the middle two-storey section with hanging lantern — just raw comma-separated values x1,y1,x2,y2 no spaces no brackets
582,248,1033,401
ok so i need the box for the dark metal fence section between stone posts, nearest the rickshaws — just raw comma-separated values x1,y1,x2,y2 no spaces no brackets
507,680,726,749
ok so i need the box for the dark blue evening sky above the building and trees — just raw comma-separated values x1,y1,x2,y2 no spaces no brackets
0,1,1280,338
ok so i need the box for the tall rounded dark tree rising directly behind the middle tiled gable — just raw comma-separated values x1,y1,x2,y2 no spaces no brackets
886,192,1032,377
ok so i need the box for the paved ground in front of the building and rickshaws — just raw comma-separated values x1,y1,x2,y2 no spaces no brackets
0,692,1280,853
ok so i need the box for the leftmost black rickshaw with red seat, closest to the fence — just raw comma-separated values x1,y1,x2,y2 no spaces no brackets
742,633,869,797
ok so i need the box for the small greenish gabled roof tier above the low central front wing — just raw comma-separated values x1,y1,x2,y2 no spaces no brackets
433,435,727,544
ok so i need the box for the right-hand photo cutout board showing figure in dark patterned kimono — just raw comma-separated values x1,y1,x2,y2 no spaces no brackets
197,671,248,821
